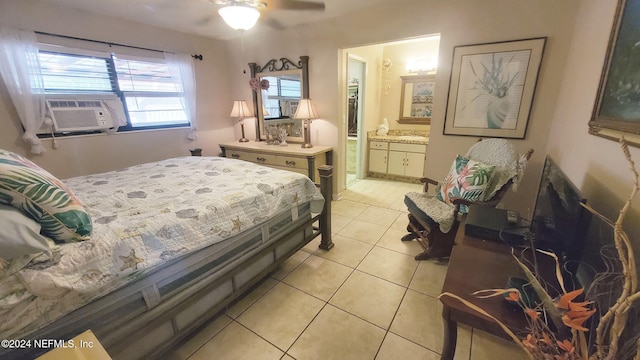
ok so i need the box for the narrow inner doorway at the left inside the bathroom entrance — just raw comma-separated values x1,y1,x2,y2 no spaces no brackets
346,54,367,188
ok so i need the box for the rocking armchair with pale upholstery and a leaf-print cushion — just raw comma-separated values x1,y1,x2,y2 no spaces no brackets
402,139,533,260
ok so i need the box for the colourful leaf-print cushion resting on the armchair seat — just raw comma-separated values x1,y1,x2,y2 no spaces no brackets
436,155,495,213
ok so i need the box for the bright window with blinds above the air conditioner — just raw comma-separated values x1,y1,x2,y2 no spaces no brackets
39,49,190,131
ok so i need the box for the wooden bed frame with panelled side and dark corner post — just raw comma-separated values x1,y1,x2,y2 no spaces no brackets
6,166,333,359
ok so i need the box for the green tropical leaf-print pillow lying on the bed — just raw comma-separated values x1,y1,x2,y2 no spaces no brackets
0,149,93,242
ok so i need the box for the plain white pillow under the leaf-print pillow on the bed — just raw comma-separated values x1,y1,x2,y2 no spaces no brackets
0,204,50,260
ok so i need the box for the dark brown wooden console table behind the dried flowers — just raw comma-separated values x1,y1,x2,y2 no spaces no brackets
440,222,553,360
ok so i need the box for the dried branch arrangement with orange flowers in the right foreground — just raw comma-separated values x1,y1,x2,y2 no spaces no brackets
440,137,640,360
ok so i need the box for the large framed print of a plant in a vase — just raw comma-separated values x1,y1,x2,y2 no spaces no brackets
444,37,547,139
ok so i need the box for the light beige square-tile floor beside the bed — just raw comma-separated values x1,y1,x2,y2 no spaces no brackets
166,179,524,360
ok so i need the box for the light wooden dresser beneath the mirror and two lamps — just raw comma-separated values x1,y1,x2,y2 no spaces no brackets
220,141,333,184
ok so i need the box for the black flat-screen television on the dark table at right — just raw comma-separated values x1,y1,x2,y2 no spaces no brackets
531,156,591,271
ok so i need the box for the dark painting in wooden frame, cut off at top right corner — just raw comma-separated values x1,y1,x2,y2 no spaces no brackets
589,0,640,147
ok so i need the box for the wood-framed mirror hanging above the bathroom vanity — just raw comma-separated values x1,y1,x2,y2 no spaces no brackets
398,75,436,124
